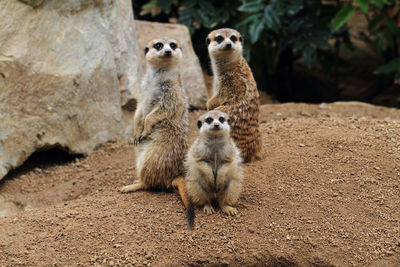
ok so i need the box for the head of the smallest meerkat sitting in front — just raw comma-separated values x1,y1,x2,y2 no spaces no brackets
197,110,231,136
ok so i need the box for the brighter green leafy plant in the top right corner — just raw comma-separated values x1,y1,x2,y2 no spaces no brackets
333,0,400,84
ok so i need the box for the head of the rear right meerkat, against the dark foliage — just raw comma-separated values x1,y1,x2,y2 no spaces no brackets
206,28,243,58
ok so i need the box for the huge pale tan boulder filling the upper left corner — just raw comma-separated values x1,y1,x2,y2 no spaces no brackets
0,0,139,179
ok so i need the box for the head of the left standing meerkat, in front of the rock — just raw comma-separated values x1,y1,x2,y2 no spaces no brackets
144,37,182,68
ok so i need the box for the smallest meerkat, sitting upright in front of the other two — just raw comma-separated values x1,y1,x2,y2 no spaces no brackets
185,110,243,227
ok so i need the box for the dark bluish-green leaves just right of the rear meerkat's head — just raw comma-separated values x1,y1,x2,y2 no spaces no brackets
235,0,340,75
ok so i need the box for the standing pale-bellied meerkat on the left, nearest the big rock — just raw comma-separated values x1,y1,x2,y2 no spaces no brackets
120,37,189,209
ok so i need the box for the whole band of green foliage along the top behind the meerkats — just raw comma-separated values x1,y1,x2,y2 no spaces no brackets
133,0,400,94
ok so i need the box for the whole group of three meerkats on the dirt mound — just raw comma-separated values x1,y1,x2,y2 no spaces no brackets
120,28,261,230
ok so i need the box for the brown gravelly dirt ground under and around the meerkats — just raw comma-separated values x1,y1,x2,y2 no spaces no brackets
0,103,400,266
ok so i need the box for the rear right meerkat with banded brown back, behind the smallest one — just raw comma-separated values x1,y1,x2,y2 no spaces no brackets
206,28,261,162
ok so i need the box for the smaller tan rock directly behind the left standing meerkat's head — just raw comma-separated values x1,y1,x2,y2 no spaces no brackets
135,20,207,109
